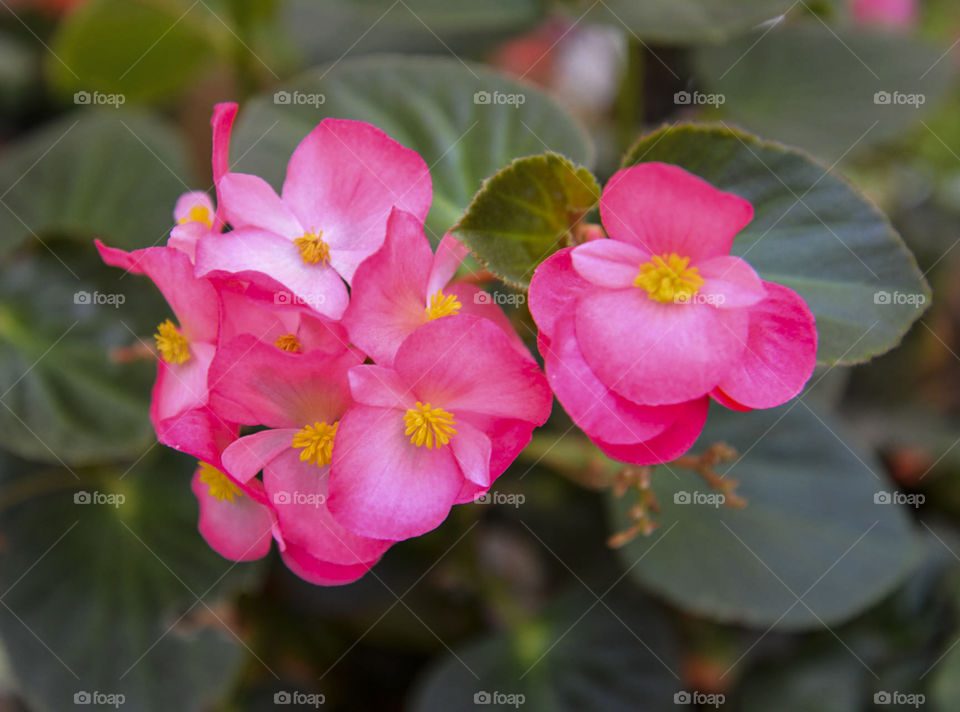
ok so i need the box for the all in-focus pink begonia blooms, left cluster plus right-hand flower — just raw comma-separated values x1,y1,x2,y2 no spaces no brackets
97,104,817,585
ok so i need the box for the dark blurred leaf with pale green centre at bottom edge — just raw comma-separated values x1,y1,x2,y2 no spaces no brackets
410,592,682,712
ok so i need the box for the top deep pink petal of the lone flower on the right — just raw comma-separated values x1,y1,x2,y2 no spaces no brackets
600,163,753,262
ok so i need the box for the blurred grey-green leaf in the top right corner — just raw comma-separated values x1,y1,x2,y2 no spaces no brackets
694,21,955,163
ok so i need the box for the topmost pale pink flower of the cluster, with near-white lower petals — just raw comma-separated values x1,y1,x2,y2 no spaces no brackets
197,119,432,319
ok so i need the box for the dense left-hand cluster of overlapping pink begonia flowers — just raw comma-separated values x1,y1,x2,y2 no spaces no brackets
97,104,552,585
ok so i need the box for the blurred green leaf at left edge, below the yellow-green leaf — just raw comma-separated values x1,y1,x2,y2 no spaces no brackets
0,109,196,257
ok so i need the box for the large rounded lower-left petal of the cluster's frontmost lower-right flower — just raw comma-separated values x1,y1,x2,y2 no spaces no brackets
328,406,464,540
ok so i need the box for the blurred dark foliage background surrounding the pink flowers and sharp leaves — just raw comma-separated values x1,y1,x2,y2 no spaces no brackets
0,0,960,712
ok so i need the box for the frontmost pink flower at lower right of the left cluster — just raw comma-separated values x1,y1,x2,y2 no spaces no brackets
329,315,552,539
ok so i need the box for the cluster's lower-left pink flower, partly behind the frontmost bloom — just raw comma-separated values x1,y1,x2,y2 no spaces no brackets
210,335,393,584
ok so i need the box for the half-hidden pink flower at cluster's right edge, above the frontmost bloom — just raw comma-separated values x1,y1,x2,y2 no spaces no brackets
343,204,532,366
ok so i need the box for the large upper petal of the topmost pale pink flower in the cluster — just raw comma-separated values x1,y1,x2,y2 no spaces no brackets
283,119,433,282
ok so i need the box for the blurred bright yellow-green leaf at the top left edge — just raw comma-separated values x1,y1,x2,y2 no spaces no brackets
47,0,230,102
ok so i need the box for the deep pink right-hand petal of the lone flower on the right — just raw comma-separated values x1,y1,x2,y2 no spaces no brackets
719,282,817,408
